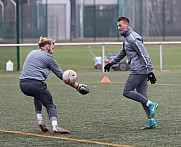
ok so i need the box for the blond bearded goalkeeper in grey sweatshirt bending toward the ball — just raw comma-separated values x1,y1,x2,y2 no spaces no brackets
20,37,89,134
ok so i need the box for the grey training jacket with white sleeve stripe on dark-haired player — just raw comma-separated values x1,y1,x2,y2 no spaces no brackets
112,27,153,74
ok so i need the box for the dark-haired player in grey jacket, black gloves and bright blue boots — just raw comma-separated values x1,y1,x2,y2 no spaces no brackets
104,17,158,130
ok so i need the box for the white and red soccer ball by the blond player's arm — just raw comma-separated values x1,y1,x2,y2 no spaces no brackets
62,69,78,84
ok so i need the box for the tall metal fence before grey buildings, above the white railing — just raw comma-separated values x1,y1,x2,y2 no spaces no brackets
0,0,181,43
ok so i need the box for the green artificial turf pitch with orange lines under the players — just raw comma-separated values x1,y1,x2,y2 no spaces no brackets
0,70,181,147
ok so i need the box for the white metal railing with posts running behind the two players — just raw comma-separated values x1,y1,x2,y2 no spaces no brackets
0,41,181,72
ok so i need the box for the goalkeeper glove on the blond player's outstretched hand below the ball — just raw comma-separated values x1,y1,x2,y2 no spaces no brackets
70,82,90,95
